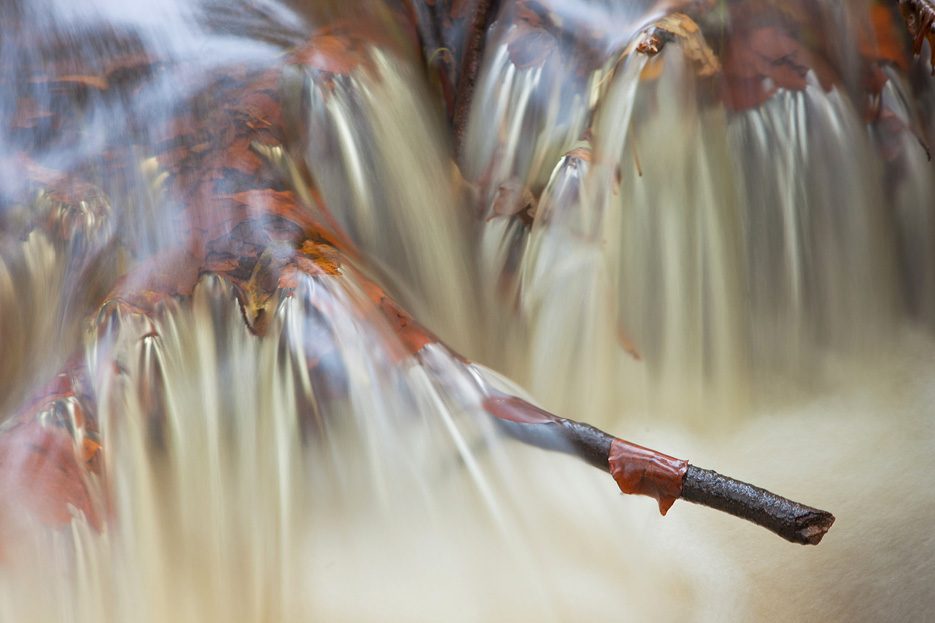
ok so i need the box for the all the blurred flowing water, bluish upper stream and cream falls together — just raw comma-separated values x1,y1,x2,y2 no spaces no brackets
0,0,935,622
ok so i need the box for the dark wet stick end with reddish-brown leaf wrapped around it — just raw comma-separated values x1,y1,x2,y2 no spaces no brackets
484,392,834,545
